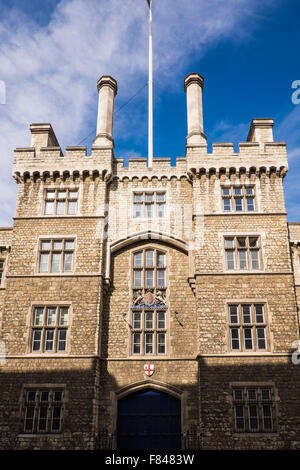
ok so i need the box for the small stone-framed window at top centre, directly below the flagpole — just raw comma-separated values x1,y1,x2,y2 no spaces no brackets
133,191,166,218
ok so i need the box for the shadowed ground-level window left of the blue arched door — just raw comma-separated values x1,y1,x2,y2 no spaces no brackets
22,387,65,434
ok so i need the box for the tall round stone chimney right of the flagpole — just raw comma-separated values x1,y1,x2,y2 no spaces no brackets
184,73,206,147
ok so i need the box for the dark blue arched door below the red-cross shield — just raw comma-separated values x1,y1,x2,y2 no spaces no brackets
117,389,181,450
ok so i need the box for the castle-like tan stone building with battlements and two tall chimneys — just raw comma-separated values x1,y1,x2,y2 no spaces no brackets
0,73,300,450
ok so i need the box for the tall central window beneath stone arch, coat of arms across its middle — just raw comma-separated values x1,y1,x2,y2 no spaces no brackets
131,248,167,355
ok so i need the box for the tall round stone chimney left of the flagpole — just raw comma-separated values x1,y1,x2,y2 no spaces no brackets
93,75,118,148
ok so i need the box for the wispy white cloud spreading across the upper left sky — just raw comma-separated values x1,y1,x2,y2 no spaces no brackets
0,0,278,225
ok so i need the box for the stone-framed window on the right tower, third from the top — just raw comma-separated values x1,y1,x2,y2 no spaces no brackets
228,302,269,352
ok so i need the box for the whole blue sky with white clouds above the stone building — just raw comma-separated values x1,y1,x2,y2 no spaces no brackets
0,0,300,226
